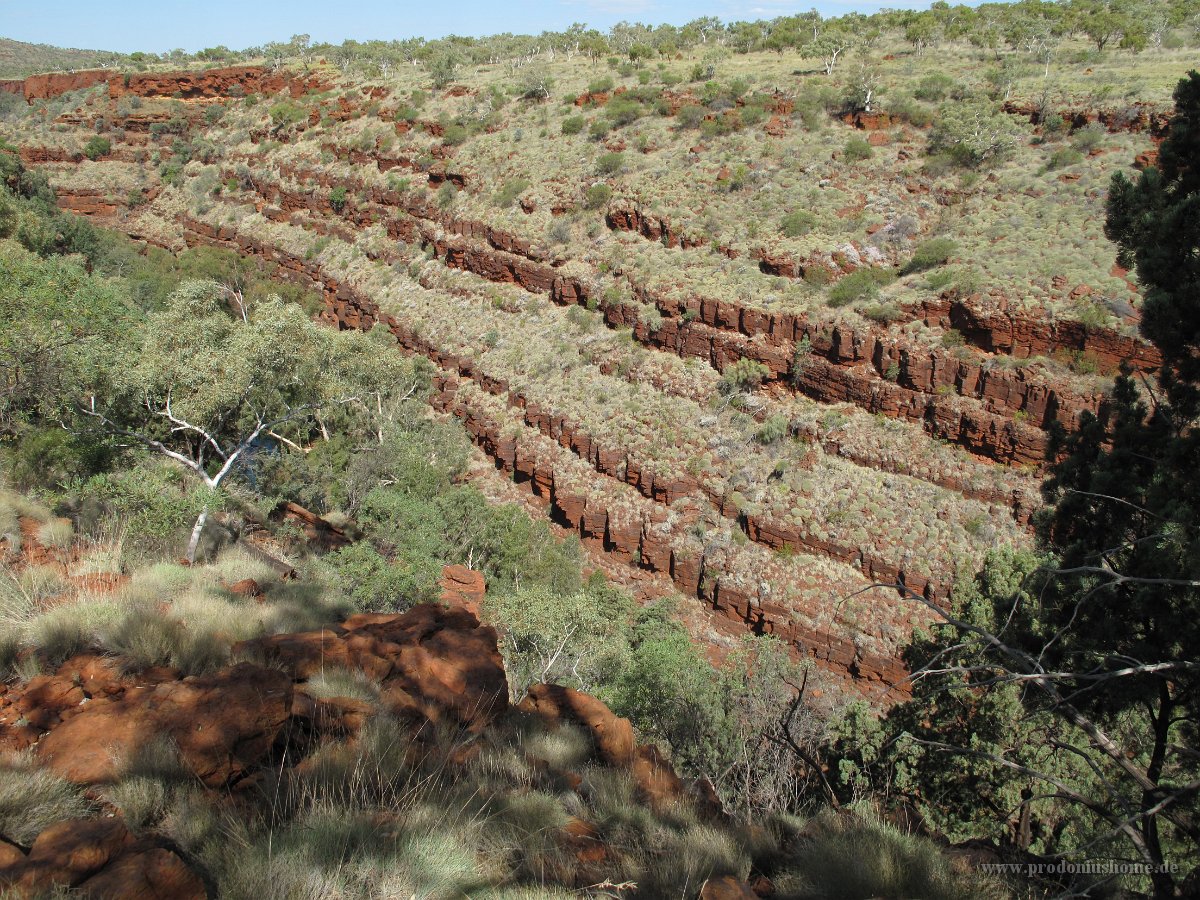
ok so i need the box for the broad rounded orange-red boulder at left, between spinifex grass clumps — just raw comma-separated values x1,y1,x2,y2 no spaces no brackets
37,664,292,786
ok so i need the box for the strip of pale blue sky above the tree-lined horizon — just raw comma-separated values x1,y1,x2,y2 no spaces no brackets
0,0,929,53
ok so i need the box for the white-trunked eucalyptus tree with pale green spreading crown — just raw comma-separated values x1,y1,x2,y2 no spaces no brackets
78,281,418,560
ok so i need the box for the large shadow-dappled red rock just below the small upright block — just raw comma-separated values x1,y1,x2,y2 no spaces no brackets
235,604,509,728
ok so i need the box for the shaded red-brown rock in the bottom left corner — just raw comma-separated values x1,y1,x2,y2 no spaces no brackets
0,818,208,900
